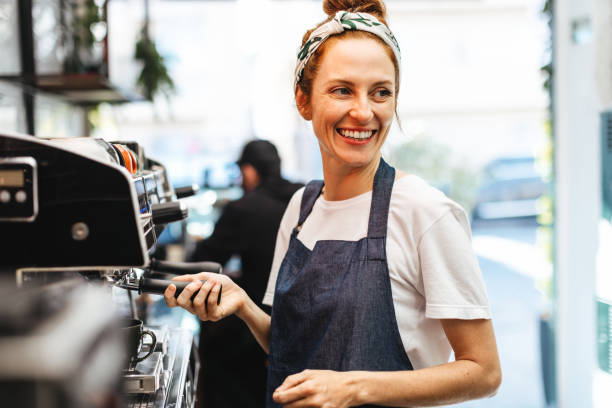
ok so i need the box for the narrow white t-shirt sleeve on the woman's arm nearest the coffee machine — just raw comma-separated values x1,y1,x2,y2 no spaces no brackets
262,187,304,306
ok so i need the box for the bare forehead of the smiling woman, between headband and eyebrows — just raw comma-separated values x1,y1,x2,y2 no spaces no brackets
315,37,395,84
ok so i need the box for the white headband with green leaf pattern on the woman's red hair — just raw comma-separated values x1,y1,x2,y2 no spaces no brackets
294,10,401,86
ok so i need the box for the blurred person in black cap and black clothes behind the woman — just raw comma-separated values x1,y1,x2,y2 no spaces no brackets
189,140,302,408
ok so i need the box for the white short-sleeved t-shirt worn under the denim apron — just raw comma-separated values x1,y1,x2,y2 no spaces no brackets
263,175,491,369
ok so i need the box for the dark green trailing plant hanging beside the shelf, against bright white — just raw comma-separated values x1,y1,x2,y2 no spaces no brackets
134,23,175,101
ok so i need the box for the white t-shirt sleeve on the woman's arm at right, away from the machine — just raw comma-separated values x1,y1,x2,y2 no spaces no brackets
419,209,491,319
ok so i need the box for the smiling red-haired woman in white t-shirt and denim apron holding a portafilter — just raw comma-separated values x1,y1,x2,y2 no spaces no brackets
165,0,501,407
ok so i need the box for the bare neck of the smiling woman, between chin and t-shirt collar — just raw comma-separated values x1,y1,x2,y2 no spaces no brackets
323,156,380,201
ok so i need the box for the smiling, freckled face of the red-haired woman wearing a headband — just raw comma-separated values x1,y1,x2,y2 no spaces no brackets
297,38,395,171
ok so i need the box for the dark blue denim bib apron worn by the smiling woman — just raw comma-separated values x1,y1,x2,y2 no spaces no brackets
267,158,412,407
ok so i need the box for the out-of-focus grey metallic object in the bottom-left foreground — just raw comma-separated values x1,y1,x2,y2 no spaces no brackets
0,280,125,408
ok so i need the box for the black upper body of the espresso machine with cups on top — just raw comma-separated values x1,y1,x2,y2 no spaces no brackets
0,134,179,270
